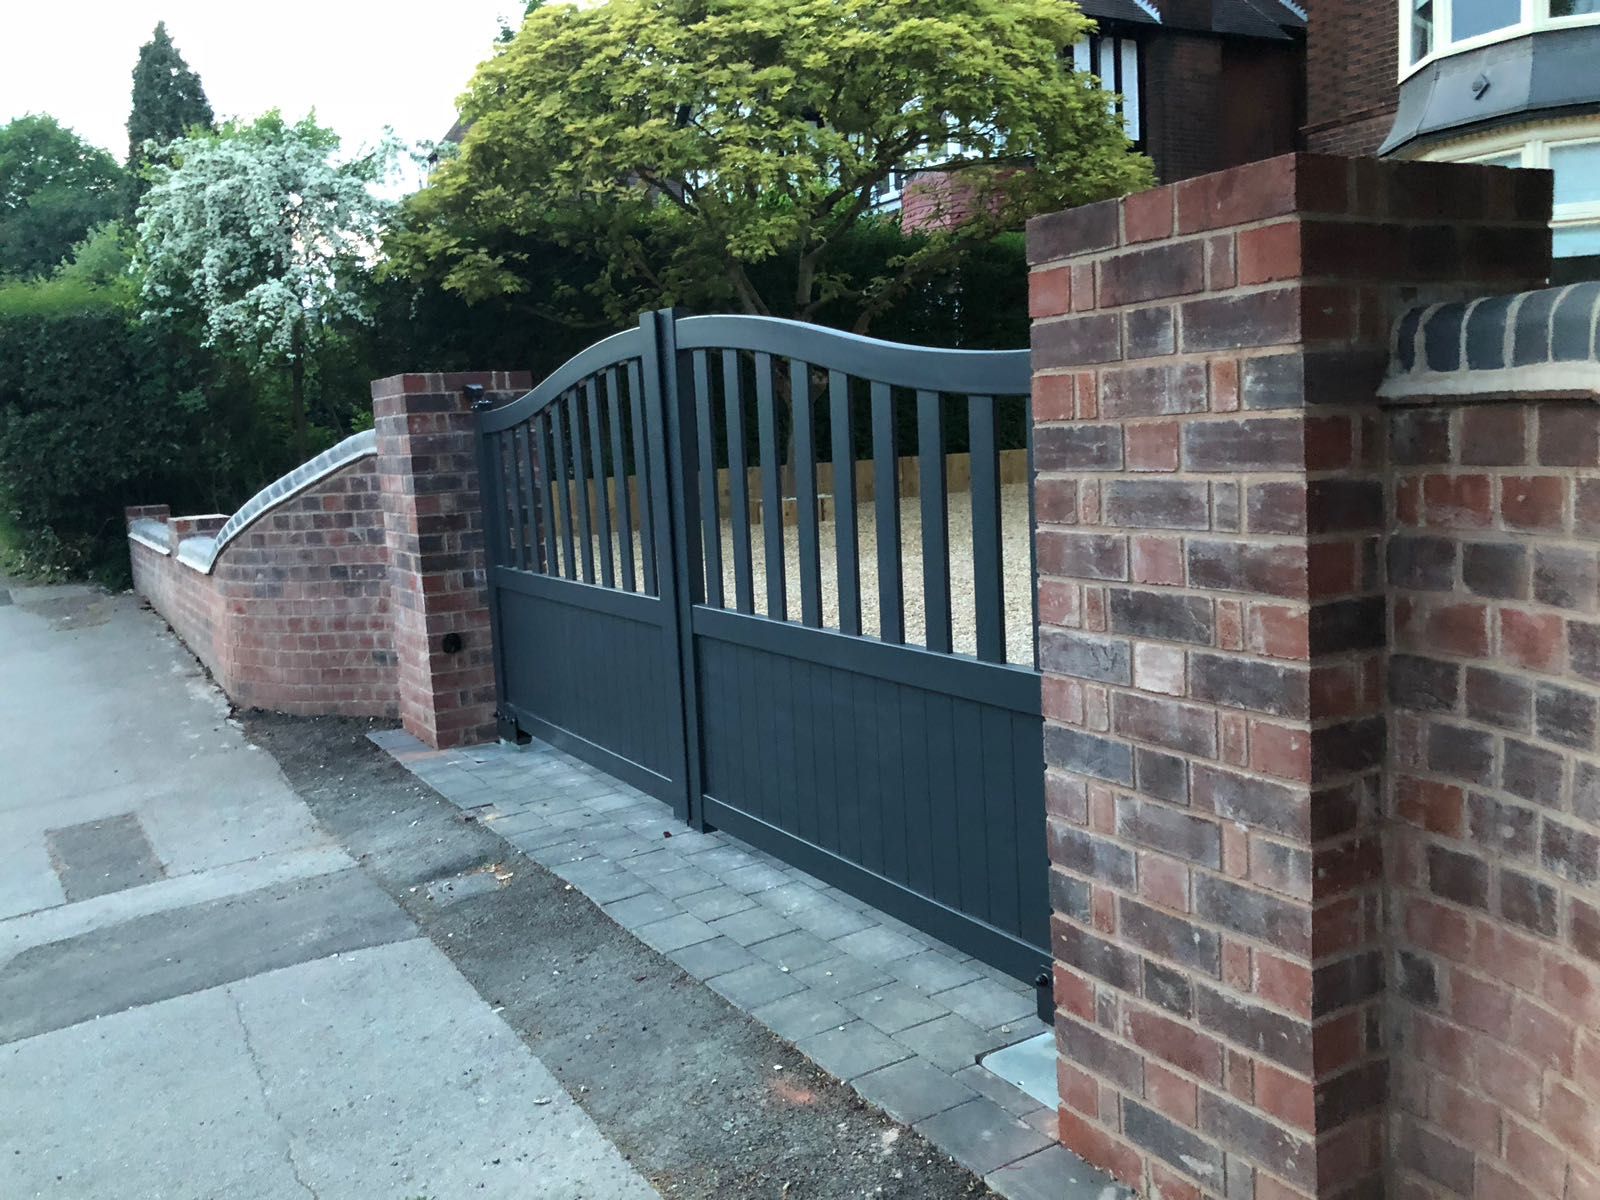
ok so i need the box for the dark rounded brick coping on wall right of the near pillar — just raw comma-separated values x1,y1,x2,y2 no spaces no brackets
1379,283,1600,400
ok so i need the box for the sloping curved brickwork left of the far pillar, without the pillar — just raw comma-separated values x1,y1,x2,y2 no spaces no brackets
128,456,398,717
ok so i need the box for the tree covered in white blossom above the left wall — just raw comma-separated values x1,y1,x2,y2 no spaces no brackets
139,112,395,456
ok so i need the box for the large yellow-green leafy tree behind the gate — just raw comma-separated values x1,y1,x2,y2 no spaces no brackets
396,0,1150,330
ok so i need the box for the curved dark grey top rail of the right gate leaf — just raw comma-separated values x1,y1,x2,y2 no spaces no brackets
677,315,1032,395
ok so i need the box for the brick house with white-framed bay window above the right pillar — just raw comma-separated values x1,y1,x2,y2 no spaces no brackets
1304,0,1600,282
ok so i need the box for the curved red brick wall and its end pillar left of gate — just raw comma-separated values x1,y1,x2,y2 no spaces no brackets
126,371,531,747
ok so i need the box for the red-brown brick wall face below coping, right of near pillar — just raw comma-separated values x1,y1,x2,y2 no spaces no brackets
1387,402,1600,1200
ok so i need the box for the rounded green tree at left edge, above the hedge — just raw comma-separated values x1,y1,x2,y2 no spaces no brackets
0,115,122,278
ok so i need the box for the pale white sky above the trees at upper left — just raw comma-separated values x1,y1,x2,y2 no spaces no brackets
0,0,523,176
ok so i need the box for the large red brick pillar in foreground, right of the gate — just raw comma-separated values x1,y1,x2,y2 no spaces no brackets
1029,155,1549,1200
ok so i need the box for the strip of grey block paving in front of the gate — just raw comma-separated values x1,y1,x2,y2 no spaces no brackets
371,730,1126,1200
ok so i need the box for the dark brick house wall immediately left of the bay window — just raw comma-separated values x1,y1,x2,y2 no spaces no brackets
1304,0,1400,154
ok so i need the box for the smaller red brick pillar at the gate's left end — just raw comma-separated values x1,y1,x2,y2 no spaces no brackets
373,371,531,747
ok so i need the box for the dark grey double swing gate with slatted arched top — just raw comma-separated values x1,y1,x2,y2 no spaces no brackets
478,312,1050,981
